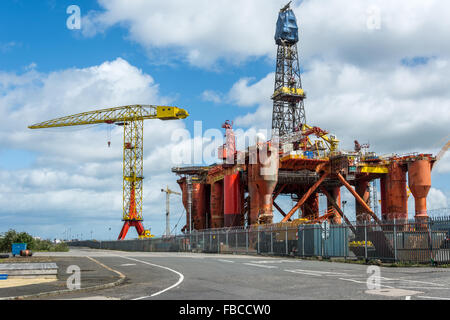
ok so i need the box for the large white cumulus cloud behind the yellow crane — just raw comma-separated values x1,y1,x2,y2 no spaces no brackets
0,58,188,237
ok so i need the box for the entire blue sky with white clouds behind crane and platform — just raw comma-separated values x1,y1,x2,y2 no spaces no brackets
0,0,450,239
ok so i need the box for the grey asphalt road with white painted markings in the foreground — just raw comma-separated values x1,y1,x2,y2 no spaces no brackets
34,249,450,300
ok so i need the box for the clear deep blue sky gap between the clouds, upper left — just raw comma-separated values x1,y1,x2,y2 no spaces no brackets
0,0,270,132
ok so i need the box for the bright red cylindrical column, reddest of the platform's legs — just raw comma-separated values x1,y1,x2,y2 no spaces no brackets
223,172,242,227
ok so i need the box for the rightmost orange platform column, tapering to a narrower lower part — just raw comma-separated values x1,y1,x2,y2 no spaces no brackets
408,160,431,221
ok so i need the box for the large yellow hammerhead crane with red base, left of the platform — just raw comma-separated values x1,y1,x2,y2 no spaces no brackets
28,105,189,240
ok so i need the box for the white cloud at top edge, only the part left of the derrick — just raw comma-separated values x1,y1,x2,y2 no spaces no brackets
83,0,284,67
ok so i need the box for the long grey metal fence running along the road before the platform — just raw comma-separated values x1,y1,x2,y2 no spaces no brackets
70,217,450,264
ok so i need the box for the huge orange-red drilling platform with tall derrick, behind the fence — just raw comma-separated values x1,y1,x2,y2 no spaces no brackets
172,5,436,232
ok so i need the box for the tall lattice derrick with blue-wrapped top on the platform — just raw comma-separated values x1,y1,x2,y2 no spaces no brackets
272,3,306,137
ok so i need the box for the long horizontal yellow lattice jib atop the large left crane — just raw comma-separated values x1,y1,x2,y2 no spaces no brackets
28,105,189,129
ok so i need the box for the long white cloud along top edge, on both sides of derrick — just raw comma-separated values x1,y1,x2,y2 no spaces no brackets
83,0,450,67
